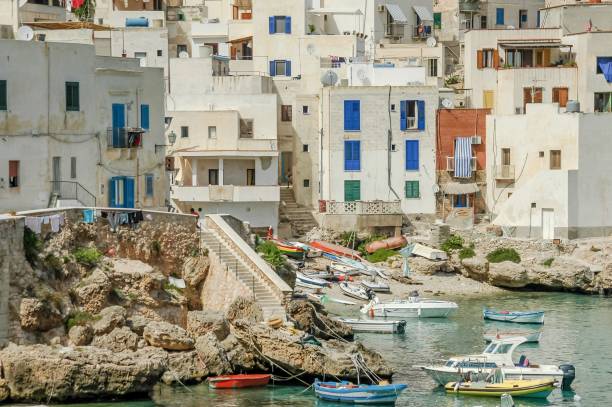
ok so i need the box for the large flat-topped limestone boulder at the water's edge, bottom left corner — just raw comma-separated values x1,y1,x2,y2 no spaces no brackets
0,345,168,402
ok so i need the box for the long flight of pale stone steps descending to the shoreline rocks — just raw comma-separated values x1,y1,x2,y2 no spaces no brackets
201,229,286,320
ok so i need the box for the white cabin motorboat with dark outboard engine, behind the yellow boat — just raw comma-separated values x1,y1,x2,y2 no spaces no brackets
415,337,575,388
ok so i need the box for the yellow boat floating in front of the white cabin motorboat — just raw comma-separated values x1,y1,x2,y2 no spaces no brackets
444,379,555,398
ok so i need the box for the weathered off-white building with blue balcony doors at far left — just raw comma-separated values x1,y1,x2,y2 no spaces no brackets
0,40,167,214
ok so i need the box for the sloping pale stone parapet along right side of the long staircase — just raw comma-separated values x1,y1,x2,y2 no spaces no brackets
206,215,293,304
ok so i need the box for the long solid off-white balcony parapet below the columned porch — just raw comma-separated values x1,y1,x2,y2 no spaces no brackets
170,185,280,202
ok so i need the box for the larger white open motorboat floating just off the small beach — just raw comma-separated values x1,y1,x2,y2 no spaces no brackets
361,296,459,318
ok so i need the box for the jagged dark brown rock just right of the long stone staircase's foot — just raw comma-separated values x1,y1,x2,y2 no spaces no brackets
287,300,353,339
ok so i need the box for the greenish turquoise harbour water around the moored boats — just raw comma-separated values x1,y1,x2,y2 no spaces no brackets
14,293,612,407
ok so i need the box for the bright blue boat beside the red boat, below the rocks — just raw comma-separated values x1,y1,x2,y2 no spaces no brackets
314,379,408,404
